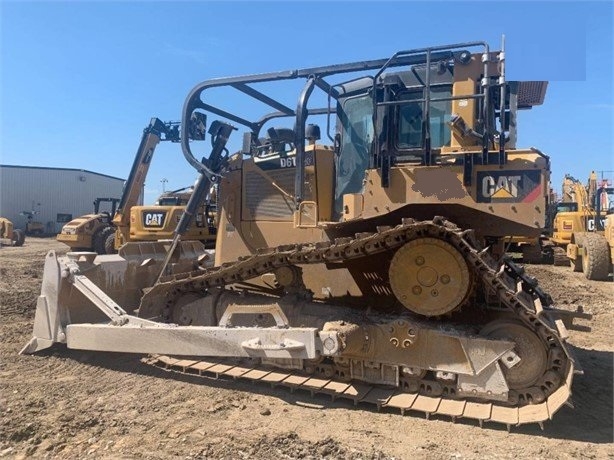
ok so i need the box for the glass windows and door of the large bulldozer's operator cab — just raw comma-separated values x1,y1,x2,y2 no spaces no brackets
335,62,453,213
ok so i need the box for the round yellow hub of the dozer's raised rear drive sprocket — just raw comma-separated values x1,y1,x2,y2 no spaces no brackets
388,238,473,316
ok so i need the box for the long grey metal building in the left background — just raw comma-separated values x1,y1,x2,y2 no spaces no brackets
0,165,124,234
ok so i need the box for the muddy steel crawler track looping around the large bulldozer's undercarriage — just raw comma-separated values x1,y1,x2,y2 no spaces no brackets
140,218,574,427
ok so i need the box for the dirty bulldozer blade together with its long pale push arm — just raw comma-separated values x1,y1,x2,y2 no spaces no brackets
21,246,338,359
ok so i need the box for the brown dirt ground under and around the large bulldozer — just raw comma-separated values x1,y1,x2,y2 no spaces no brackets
0,238,614,459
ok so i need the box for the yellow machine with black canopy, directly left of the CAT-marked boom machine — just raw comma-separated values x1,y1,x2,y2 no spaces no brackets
56,197,120,254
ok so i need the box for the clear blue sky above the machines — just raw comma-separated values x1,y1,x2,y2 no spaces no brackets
0,0,614,203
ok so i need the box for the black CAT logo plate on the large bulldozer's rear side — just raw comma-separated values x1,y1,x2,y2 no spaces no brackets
477,169,543,203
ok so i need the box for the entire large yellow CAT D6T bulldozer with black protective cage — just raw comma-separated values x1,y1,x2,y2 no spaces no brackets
23,42,590,428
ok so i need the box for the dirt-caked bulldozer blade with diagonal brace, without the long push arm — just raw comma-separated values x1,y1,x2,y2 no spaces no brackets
20,241,211,354
